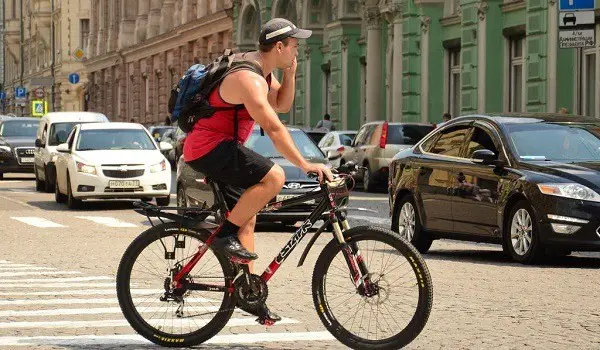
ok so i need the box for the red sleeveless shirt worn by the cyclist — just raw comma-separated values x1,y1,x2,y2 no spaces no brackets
183,74,271,162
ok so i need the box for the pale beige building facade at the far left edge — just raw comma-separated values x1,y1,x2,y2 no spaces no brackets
3,0,90,115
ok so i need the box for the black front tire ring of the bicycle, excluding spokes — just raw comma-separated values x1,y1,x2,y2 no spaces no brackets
312,226,433,349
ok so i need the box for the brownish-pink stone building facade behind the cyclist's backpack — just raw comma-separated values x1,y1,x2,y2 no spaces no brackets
85,0,233,125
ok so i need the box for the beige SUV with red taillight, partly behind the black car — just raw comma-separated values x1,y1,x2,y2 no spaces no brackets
341,121,434,192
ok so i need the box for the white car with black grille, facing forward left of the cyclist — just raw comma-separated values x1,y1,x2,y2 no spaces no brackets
55,123,172,209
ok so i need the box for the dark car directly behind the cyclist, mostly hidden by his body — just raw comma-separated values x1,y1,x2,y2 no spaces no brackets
177,127,348,225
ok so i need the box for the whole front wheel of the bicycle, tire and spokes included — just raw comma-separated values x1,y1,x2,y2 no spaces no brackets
312,226,433,349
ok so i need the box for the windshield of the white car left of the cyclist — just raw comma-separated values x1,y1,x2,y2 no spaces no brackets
77,129,156,151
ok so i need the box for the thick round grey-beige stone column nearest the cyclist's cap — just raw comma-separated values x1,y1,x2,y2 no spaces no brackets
366,8,382,122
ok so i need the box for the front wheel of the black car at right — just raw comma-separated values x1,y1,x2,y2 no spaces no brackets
503,200,544,264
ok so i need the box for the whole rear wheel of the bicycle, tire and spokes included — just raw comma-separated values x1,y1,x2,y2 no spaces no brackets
117,223,236,347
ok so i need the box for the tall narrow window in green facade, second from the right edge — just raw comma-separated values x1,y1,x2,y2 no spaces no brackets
508,37,525,112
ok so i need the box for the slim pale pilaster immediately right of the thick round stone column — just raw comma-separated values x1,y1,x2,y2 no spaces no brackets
392,5,402,122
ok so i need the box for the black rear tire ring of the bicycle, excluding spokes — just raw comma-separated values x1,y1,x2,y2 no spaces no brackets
116,222,236,347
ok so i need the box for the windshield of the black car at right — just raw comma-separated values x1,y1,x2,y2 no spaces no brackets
506,123,600,162
